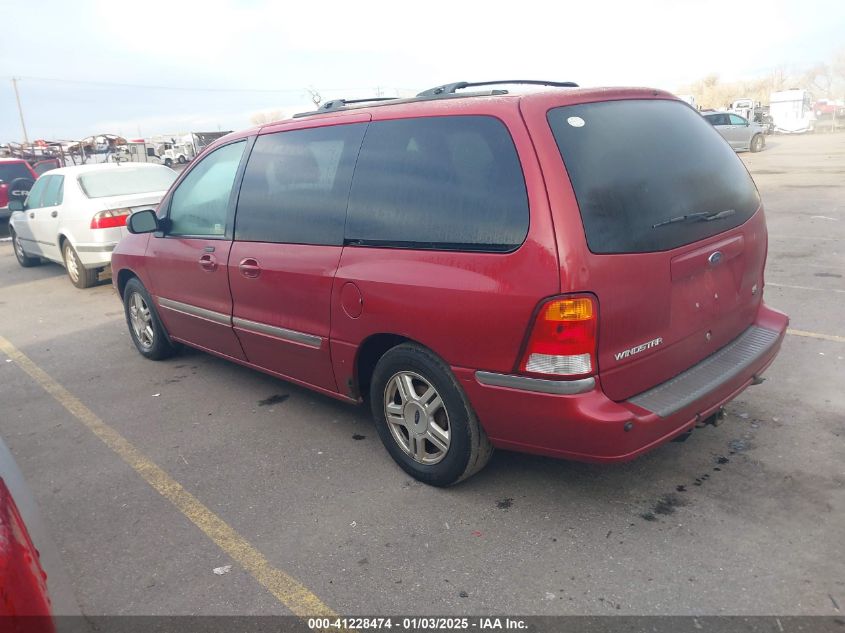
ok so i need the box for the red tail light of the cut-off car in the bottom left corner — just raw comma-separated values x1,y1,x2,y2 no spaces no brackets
0,479,55,633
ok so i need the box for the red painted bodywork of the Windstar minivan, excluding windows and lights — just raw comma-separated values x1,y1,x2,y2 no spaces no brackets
112,90,788,461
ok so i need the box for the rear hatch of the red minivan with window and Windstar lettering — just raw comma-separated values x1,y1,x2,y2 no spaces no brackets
547,99,767,400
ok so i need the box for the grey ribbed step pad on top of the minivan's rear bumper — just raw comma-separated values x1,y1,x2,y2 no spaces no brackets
628,325,780,418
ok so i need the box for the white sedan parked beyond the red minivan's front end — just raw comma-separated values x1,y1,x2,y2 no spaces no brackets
9,164,177,288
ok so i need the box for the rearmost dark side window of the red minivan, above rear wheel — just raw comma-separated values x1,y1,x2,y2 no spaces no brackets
346,116,529,251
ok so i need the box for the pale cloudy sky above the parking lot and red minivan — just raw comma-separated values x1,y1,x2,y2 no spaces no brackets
0,0,845,143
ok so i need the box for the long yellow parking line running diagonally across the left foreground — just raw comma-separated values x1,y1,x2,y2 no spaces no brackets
0,336,335,618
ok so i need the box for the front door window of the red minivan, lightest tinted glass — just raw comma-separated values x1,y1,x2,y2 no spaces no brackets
168,141,246,236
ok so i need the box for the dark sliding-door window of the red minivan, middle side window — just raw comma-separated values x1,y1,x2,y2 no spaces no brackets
235,123,366,246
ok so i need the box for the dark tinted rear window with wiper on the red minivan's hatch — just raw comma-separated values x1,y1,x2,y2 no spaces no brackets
548,99,760,253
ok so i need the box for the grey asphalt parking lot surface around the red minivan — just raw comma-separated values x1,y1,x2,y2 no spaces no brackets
0,134,845,615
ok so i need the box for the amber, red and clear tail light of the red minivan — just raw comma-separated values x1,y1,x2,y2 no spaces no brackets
519,296,598,378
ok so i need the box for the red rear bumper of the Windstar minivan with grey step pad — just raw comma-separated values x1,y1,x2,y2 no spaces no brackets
453,305,789,462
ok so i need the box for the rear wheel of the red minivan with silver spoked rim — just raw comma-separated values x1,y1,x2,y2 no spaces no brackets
370,343,493,486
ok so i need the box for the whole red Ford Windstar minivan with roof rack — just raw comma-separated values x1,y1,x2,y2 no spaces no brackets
112,81,788,486
